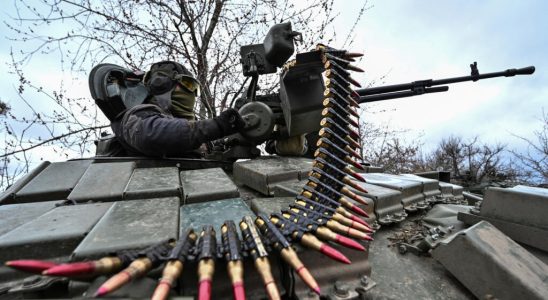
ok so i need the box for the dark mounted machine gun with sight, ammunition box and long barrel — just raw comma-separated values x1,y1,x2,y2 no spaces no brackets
210,23,535,159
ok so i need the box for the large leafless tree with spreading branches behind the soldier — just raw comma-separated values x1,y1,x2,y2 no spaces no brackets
0,0,368,187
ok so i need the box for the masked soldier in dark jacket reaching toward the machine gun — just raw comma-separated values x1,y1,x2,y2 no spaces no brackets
111,61,245,157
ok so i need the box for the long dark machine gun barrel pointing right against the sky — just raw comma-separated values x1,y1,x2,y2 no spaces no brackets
356,62,535,103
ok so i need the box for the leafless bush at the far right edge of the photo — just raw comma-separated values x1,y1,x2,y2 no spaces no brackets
511,110,548,185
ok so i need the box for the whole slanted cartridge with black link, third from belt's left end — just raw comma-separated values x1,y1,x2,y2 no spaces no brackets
94,242,171,297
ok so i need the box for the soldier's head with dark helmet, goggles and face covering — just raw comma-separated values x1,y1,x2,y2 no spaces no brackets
144,61,200,119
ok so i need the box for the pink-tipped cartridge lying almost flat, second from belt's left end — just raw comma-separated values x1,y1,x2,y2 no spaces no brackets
42,256,123,277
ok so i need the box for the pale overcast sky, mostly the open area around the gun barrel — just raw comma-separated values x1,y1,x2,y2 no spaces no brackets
0,0,548,161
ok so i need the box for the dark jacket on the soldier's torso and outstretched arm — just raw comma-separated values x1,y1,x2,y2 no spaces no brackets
111,104,222,157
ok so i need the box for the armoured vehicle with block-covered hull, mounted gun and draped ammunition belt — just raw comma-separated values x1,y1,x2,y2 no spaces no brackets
0,23,548,299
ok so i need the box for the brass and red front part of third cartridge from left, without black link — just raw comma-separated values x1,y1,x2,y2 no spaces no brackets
94,257,152,297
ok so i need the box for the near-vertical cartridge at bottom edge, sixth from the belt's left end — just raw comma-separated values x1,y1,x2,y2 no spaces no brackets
221,221,245,300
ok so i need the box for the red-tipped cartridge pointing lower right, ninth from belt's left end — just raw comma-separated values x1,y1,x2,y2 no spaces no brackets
270,211,350,264
